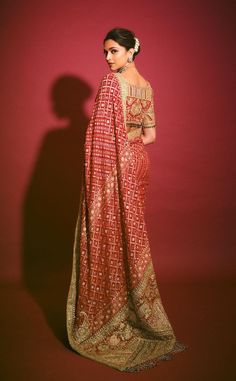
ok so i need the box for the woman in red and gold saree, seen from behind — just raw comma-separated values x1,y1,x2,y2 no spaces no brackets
67,29,185,372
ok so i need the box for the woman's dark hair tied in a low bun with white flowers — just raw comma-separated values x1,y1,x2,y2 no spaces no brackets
103,28,140,59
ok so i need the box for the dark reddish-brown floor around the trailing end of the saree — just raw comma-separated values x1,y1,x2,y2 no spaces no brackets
0,279,236,381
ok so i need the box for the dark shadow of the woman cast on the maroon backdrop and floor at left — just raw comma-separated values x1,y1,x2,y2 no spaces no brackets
22,76,92,345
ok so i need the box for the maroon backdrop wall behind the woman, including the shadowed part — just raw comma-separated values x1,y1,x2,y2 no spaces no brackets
0,0,236,280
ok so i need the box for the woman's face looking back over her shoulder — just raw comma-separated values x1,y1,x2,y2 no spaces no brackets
104,40,132,71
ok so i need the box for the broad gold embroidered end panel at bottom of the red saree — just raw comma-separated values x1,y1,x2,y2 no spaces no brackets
69,262,176,370
